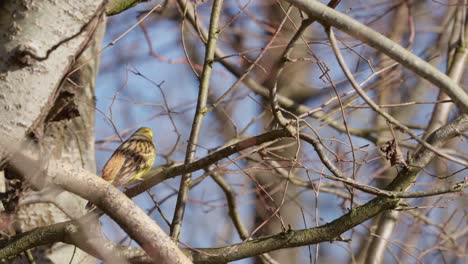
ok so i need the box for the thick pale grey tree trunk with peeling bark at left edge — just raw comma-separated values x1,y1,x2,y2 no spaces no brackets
0,0,105,263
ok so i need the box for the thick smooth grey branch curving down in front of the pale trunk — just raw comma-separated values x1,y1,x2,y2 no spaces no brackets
1,137,190,263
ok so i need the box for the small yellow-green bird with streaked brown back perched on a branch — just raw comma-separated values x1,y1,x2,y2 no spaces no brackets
86,127,156,211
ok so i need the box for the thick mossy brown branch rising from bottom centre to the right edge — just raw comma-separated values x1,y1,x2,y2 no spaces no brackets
185,115,468,263
